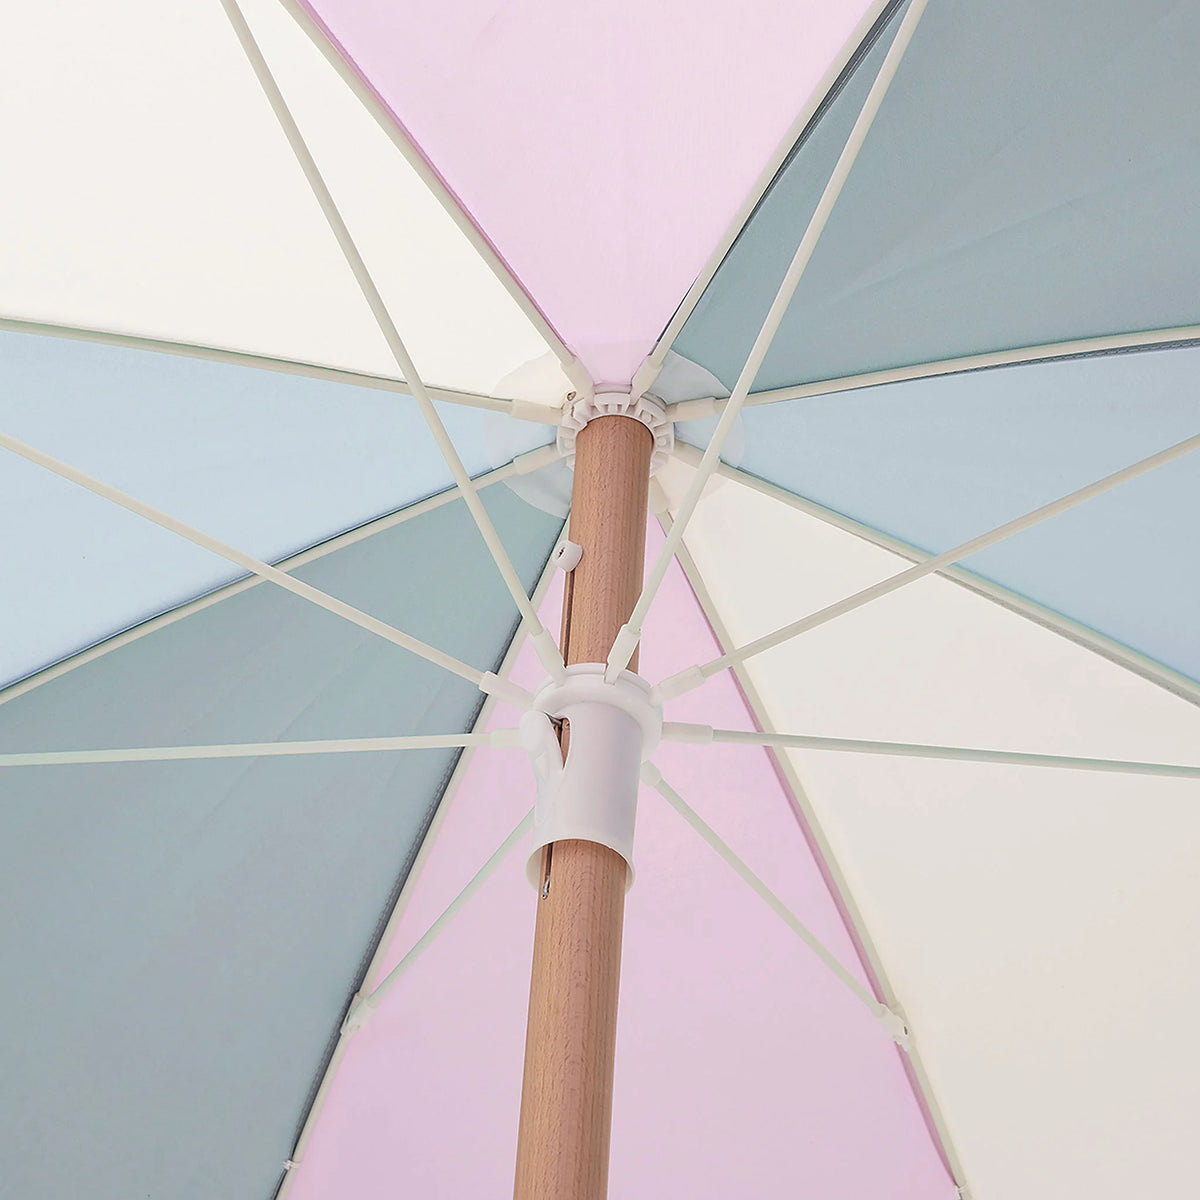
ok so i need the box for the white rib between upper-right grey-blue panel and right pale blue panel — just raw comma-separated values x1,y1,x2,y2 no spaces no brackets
667,325,1200,421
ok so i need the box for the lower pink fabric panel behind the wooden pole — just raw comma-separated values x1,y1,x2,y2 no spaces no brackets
285,529,954,1200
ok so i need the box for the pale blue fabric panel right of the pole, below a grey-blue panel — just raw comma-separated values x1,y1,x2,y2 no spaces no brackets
677,348,1200,679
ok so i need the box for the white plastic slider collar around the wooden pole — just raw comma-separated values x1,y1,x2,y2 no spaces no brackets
521,662,662,890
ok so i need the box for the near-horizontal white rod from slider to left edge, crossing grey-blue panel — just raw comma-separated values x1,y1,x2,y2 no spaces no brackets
0,730,517,767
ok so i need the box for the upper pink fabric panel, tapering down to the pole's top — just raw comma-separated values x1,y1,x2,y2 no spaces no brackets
295,0,869,382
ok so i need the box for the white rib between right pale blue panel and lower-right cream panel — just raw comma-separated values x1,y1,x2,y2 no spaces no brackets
664,442,1200,707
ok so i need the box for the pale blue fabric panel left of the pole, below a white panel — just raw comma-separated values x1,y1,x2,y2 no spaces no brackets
0,331,553,683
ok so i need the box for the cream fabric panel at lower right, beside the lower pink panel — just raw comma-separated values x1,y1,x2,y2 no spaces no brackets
665,464,1200,1200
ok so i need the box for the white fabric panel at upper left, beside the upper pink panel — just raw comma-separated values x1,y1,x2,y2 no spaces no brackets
0,0,566,398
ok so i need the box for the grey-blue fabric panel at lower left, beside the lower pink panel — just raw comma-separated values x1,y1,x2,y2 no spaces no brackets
0,487,560,1200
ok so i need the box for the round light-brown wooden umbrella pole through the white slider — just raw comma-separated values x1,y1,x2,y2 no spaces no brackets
514,416,653,1200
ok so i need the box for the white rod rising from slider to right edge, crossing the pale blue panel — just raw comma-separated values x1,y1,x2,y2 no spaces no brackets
659,433,1200,697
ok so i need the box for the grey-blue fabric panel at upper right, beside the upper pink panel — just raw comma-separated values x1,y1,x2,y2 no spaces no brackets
670,0,1200,398
